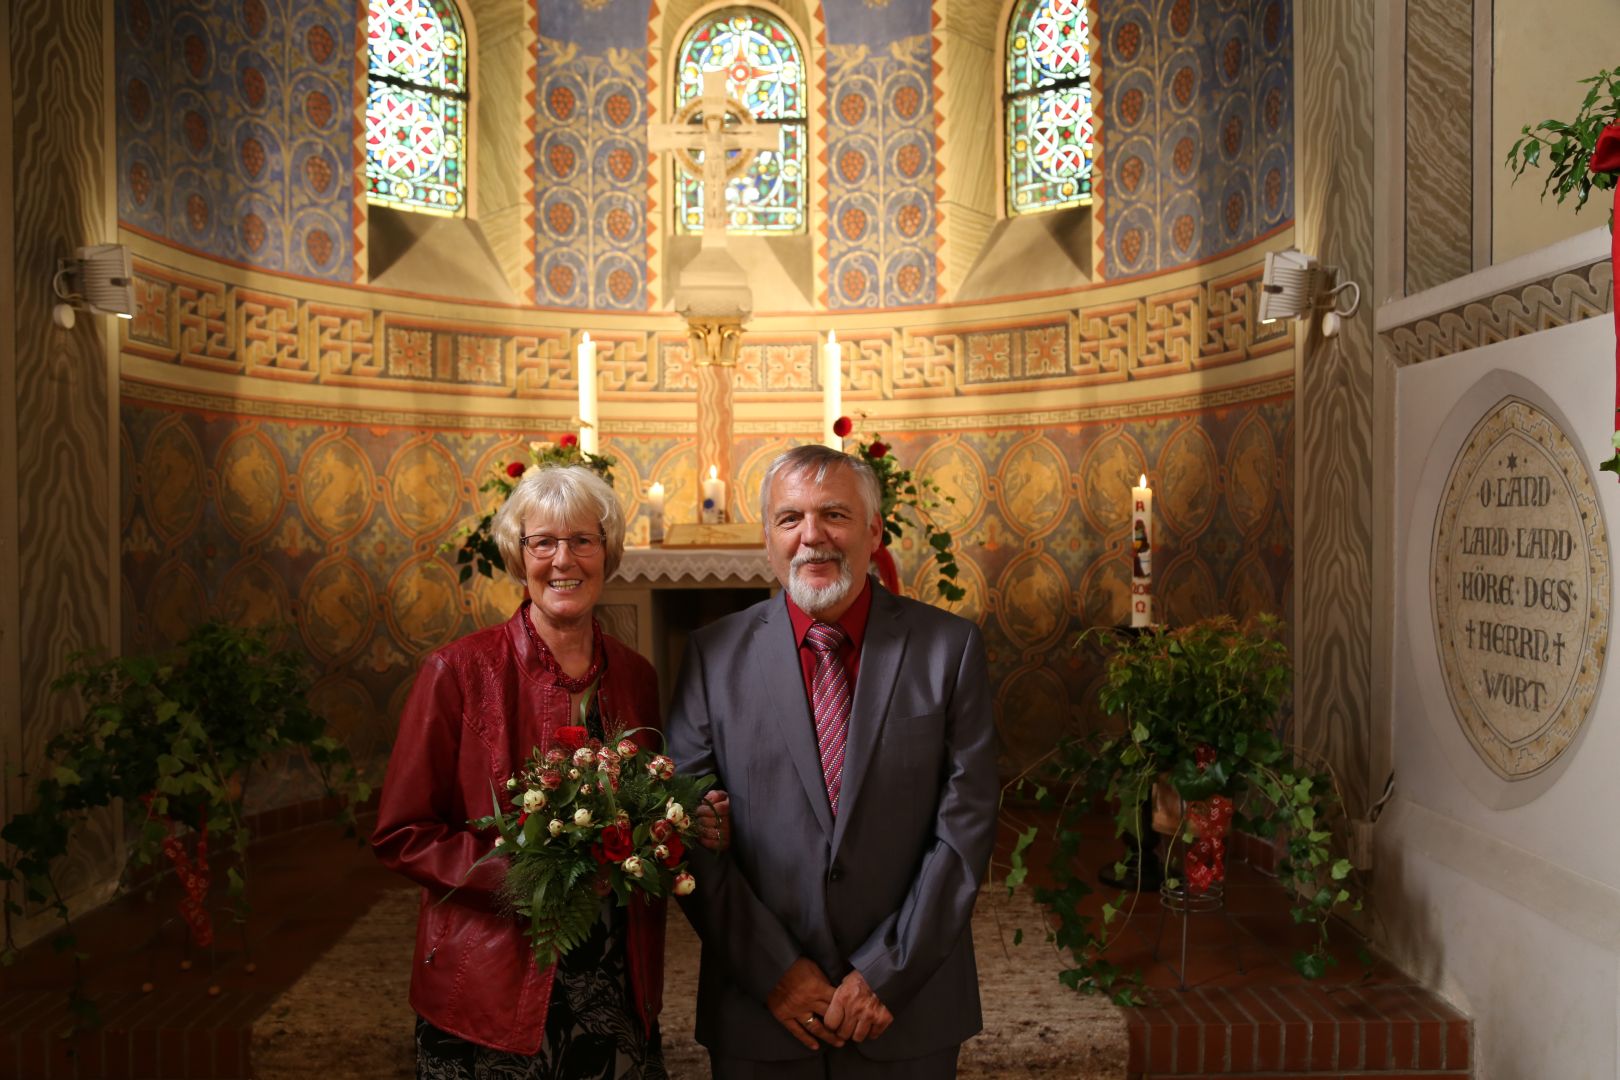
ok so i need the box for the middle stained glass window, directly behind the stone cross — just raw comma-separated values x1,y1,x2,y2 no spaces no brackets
676,8,805,235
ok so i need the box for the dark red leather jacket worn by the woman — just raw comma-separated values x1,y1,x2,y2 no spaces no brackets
371,604,664,1054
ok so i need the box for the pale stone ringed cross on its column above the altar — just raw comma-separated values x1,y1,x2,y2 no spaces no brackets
646,71,776,518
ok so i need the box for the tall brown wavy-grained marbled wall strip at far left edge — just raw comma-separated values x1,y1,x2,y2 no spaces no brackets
11,0,122,919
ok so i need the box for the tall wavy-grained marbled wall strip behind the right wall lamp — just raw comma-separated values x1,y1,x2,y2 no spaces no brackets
1294,0,1383,813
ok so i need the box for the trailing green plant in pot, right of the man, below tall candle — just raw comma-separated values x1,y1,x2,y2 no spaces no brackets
1008,615,1358,1004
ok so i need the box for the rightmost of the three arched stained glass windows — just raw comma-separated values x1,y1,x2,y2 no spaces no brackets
1004,0,1092,214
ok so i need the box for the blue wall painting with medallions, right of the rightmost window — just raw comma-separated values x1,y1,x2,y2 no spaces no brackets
1097,0,1294,277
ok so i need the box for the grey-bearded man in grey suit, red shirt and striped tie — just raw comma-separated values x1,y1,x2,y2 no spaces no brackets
669,445,998,1080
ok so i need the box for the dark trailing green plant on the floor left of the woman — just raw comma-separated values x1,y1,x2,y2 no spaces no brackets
0,622,369,1020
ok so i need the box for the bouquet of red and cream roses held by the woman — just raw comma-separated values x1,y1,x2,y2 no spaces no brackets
470,727,714,967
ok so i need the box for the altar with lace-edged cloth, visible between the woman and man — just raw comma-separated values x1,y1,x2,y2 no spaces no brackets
596,547,778,714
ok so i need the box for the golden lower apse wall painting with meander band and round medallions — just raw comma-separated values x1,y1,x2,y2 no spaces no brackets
120,242,1293,786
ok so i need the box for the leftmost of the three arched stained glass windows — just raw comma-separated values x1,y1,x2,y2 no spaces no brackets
366,0,467,214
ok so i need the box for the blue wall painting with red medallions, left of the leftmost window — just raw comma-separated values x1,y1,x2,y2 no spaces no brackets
115,0,365,282
